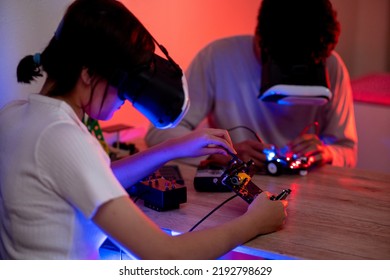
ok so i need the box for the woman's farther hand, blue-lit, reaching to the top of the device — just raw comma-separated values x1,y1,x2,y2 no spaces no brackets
167,128,236,157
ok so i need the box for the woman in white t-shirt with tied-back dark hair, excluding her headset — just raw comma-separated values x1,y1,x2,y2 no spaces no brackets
0,0,286,259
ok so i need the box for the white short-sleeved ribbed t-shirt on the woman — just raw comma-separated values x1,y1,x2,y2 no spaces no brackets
0,94,127,259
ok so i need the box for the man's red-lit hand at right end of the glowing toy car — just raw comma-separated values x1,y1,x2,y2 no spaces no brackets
288,134,333,165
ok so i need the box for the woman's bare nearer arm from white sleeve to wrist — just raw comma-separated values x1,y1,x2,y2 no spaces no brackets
93,197,262,259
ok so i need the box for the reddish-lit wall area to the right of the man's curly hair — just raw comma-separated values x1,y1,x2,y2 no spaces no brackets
331,0,390,78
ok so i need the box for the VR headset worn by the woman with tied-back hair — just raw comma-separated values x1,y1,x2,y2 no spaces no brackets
118,50,190,129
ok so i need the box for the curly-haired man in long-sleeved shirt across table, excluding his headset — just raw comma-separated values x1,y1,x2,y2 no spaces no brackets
146,0,357,168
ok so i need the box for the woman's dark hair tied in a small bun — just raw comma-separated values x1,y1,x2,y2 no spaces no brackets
17,0,155,96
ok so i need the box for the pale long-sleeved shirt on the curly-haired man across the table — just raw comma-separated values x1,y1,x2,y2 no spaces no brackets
146,35,357,166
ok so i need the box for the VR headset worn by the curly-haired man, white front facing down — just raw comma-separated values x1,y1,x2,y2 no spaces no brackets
258,56,332,105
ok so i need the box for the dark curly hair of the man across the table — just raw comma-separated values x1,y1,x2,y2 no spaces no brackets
256,0,340,63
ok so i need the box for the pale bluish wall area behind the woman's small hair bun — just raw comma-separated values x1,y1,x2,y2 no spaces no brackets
0,0,71,107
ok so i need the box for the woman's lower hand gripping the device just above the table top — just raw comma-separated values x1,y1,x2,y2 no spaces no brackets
246,191,288,234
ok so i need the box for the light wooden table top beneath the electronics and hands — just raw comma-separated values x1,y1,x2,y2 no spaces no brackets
133,164,390,260
